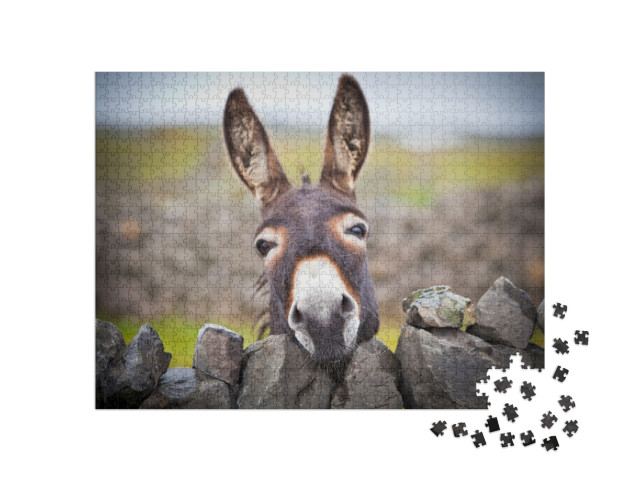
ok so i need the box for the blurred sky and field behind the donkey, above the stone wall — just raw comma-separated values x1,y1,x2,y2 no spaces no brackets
96,73,544,367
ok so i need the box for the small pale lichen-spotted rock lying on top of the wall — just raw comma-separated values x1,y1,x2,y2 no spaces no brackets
403,286,471,329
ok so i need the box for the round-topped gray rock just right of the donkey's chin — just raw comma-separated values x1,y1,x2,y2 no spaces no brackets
331,337,402,409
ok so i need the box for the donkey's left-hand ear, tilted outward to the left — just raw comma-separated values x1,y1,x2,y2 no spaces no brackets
223,88,291,207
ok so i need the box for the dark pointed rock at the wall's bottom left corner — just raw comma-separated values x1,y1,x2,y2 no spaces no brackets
96,324,171,408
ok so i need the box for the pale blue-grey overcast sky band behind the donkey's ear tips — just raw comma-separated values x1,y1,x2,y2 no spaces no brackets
96,73,544,148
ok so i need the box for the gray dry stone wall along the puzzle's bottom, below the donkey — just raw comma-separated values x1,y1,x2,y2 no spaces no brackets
96,277,544,409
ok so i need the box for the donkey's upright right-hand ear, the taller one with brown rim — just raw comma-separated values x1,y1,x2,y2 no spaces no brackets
320,74,370,196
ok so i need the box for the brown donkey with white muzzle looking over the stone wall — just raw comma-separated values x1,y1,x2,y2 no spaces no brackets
223,75,379,363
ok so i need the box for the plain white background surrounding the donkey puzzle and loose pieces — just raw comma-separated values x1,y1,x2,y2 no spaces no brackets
0,0,640,480
